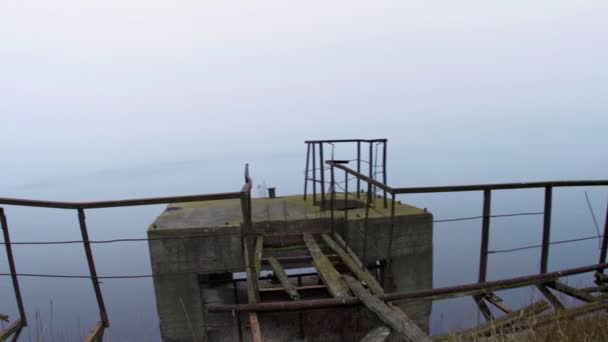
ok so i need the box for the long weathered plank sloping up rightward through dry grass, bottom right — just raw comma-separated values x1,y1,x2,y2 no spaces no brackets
433,300,550,341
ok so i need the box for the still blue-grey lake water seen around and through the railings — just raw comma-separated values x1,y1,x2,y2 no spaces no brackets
0,143,608,341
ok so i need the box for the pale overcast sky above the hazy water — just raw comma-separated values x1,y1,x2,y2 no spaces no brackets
0,0,608,183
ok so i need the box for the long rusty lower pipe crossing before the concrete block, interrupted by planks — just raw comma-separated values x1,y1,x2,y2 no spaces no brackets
208,263,608,312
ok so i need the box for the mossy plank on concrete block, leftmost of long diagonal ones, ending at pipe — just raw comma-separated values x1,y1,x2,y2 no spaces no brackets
303,233,350,298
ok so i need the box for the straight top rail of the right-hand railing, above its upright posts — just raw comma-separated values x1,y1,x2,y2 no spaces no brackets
393,180,608,194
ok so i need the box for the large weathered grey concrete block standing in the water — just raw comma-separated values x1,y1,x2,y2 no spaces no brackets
148,196,433,341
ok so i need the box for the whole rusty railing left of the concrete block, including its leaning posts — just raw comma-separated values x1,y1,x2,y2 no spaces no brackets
0,165,252,341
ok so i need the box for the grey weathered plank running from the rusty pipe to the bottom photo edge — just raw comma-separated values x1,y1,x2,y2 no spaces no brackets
343,275,431,342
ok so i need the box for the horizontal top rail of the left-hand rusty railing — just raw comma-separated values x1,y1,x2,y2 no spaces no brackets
0,191,243,209
